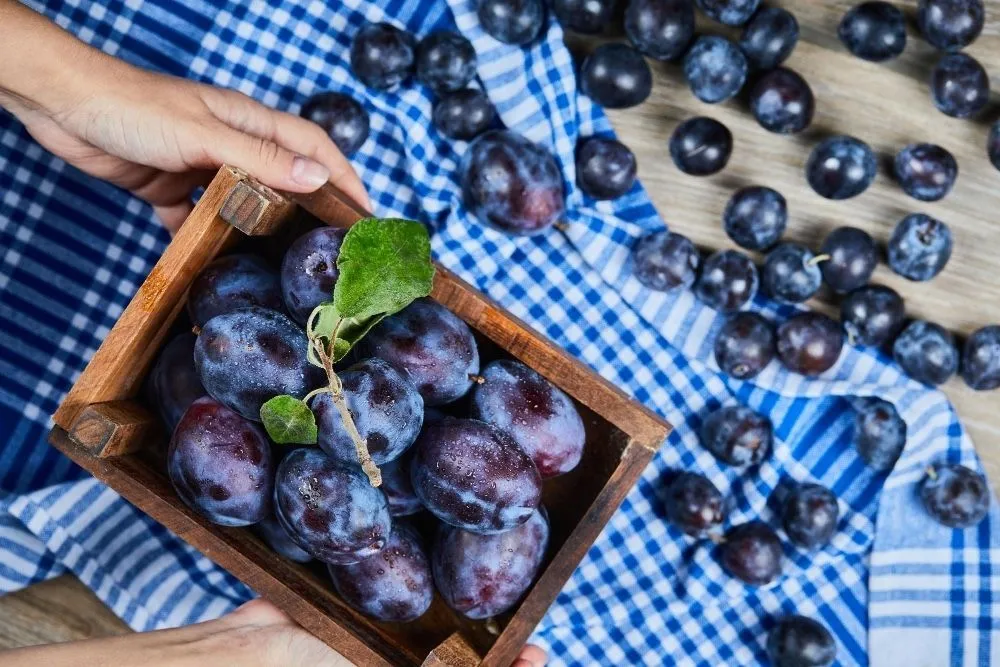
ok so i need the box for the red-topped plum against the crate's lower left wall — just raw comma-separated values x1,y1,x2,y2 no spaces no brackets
167,396,274,526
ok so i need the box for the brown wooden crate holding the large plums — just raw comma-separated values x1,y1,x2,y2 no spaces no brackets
50,167,669,667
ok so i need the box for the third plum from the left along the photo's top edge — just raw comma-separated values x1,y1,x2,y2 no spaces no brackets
625,0,694,61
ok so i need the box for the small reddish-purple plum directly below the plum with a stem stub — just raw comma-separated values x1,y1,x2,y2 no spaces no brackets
778,312,844,375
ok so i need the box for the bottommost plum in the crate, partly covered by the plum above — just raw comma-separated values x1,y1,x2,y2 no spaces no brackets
327,523,434,623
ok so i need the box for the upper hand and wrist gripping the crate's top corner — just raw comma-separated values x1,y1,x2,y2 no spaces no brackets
0,0,369,231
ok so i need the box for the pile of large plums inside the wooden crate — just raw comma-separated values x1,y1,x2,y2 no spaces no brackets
149,228,585,621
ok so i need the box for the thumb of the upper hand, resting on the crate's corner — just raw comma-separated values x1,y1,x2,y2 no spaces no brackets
211,125,330,192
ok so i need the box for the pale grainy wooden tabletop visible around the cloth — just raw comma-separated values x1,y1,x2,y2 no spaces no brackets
0,0,1000,648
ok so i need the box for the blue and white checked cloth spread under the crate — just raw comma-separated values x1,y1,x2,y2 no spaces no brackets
0,0,1000,667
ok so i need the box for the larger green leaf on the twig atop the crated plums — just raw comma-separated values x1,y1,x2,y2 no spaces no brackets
333,218,434,322
